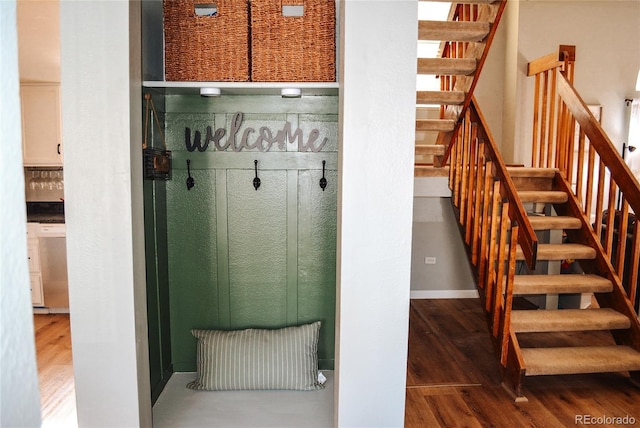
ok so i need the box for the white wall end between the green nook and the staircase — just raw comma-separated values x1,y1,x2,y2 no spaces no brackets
335,0,418,427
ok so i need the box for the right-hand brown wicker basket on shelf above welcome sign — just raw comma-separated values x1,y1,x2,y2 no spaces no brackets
251,0,336,82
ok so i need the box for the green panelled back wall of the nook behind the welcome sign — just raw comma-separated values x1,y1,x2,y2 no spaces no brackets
165,96,338,371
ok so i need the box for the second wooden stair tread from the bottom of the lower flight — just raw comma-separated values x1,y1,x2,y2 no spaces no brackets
511,308,631,333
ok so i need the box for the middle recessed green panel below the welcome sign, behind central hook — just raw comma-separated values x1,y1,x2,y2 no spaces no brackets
227,170,287,329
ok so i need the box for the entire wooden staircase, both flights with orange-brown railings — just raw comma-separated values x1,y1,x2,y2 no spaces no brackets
415,0,640,401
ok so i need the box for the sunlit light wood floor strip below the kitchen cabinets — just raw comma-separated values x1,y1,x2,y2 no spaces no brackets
33,314,78,428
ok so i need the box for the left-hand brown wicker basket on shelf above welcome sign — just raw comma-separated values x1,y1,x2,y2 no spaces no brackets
164,0,249,82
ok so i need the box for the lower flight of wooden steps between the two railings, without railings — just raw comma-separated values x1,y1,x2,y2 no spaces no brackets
507,168,640,399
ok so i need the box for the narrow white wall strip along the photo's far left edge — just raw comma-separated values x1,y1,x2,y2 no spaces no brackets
0,1,40,427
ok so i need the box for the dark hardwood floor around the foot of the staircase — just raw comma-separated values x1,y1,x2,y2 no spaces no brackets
405,299,640,427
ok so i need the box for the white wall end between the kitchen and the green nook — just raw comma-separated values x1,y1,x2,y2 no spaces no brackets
60,1,151,427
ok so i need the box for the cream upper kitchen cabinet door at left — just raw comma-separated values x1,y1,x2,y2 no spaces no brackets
20,83,62,166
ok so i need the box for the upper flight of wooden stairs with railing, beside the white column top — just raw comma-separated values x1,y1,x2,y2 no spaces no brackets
415,0,506,177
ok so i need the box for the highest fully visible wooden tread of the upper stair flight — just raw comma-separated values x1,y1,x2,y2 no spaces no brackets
418,21,491,42
